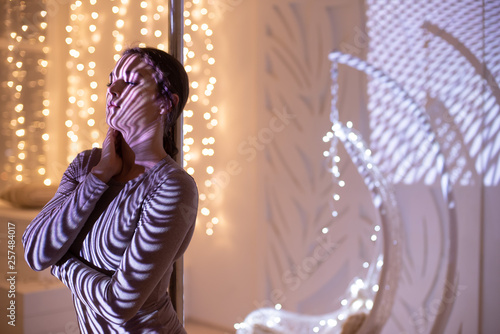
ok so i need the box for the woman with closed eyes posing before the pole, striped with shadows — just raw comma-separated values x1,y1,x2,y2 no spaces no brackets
23,48,198,334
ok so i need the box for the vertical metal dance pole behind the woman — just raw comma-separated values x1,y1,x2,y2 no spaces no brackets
168,0,184,325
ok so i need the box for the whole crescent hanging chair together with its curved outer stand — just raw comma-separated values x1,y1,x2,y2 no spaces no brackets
235,47,457,334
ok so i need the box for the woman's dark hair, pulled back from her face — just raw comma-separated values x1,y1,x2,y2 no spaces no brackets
123,47,189,159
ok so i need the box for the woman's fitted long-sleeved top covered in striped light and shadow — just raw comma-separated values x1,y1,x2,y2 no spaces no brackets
23,149,198,334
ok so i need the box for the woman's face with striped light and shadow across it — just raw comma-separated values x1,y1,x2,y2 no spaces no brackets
106,54,160,137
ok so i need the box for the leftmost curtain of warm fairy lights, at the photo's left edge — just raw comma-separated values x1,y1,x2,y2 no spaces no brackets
1,1,51,185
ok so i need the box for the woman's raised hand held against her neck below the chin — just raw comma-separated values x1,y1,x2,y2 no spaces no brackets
92,128,126,183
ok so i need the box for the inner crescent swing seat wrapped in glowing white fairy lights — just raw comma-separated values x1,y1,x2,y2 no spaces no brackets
235,53,401,334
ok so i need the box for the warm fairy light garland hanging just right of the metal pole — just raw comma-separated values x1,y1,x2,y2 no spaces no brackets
183,0,219,236
